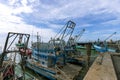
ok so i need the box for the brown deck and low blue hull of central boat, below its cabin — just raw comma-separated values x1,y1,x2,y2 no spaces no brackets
28,60,82,80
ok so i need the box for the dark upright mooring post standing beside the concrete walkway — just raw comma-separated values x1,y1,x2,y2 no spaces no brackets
86,43,92,68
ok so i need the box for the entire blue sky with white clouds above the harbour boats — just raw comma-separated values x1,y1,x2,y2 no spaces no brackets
0,0,120,45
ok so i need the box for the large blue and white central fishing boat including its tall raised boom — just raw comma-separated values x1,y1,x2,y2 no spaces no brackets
26,20,81,80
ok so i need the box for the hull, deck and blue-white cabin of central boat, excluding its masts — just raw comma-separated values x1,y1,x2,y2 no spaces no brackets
26,43,81,80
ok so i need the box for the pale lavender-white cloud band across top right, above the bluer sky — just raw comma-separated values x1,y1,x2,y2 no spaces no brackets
29,0,120,19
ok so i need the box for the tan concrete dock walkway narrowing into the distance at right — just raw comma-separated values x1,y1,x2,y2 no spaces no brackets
83,53,118,80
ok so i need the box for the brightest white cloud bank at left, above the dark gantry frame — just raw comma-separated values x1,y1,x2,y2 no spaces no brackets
0,4,56,46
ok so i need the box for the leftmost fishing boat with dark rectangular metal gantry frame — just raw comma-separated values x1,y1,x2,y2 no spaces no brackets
0,32,38,80
